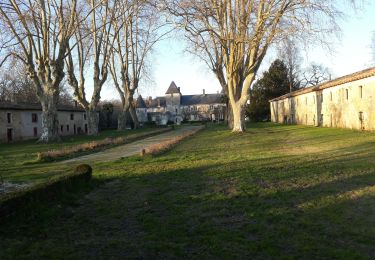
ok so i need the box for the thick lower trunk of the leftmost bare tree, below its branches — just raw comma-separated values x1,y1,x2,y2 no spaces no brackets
39,94,60,143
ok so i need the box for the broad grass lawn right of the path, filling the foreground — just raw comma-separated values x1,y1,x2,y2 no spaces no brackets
0,123,375,259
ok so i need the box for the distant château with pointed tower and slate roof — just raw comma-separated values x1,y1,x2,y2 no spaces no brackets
137,81,226,125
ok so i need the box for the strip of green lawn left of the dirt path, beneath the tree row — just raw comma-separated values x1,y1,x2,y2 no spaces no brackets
0,127,164,183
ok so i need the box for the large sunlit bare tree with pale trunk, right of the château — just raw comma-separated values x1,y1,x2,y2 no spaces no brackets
166,0,358,132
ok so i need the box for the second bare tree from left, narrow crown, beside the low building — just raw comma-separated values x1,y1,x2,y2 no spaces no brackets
66,0,118,135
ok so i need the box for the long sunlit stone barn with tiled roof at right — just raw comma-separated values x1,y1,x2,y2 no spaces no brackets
270,67,375,130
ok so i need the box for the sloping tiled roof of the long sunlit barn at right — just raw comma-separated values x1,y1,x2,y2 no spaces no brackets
270,67,375,101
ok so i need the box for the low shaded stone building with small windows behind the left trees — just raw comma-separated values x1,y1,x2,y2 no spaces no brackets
0,102,87,142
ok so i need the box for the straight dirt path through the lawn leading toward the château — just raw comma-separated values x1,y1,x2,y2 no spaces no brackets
60,126,201,164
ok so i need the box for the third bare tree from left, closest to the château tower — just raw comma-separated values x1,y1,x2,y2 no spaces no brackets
110,0,170,130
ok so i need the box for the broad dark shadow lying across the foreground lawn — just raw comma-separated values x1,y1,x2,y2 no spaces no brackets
0,154,375,258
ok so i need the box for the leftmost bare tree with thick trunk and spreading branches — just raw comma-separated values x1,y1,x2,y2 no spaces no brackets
0,0,81,142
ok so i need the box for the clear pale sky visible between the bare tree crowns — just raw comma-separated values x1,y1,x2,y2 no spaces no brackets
102,0,375,100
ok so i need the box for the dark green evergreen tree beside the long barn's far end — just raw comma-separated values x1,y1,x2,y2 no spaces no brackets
247,59,298,121
